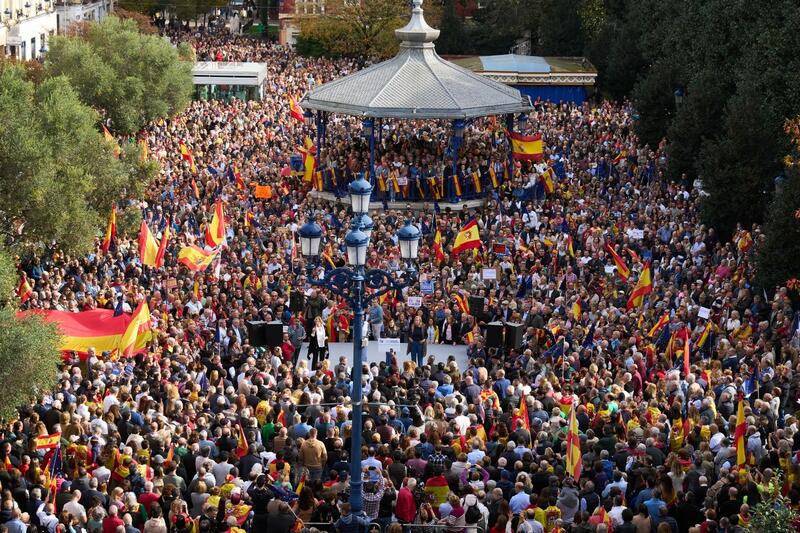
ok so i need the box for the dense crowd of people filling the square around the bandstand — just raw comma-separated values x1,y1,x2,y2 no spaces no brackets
0,27,800,533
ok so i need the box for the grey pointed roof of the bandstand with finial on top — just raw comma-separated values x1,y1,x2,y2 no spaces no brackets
301,0,531,119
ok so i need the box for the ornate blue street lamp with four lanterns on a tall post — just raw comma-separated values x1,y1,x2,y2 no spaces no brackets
298,178,421,513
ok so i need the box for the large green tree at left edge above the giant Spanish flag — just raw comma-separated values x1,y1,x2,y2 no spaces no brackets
0,66,154,253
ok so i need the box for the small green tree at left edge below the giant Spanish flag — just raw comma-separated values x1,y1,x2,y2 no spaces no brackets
0,306,61,420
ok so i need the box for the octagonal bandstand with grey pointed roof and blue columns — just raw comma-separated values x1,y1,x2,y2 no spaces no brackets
301,0,531,208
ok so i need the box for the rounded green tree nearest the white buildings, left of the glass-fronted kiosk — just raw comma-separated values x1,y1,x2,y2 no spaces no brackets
45,17,192,134
